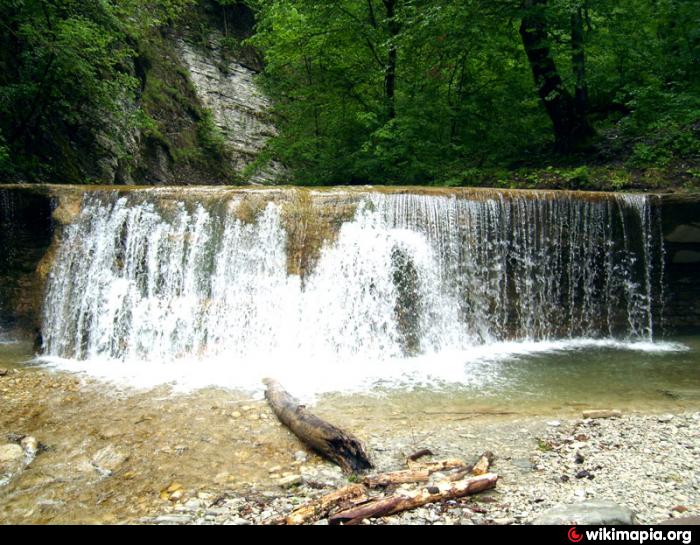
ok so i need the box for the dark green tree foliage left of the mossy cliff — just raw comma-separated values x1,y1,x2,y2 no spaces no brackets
0,0,193,181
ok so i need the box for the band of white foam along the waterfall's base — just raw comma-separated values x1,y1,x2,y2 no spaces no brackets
37,338,688,400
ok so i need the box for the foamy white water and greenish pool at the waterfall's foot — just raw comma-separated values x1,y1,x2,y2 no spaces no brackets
28,337,700,410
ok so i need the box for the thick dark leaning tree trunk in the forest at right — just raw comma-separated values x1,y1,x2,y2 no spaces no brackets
520,0,595,153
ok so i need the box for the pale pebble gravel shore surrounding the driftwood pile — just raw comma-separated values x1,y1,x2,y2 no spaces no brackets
140,412,700,525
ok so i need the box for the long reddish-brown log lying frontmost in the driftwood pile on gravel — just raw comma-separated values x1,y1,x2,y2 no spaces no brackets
328,473,498,525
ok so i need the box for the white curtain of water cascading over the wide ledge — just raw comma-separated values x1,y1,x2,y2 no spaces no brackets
43,191,663,391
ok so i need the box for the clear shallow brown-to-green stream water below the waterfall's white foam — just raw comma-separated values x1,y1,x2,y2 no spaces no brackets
0,337,700,523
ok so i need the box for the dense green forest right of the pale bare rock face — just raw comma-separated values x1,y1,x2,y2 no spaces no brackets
253,0,700,187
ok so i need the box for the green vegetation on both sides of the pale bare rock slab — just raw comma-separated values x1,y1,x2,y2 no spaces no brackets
0,0,700,188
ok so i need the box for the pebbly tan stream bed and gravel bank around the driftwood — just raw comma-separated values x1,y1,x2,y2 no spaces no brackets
0,367,700,524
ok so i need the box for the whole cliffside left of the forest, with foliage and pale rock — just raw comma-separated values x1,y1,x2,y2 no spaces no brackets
0,0,280,185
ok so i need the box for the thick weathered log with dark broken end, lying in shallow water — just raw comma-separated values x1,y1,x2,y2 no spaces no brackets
263,379,372,473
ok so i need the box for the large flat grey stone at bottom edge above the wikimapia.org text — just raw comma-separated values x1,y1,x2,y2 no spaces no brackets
532,501,636,526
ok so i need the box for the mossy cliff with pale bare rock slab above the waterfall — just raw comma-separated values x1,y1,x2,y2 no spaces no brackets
52,0,284,185
